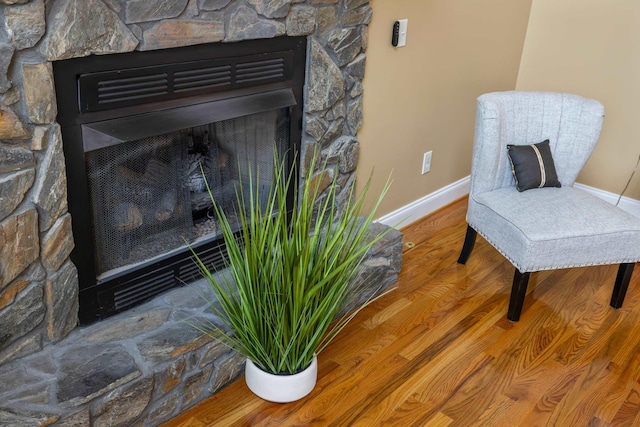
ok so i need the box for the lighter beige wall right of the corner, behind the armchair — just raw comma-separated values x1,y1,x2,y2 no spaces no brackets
516,0,640,199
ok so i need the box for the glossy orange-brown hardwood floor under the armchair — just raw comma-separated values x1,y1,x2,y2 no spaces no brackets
165,199,640,427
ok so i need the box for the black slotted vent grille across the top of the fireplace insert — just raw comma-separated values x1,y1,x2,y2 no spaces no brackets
78,51,293,113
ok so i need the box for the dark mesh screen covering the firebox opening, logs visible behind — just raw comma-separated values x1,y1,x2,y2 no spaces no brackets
86,108,289,276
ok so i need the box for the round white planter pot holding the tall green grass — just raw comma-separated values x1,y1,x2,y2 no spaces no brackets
244,357,318,403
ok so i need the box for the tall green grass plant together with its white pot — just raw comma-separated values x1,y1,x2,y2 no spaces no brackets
188,155,389,402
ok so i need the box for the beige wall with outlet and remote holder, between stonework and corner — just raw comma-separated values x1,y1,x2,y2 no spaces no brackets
358,0,532,216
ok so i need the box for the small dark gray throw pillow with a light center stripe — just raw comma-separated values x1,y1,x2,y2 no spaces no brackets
507,139,560,191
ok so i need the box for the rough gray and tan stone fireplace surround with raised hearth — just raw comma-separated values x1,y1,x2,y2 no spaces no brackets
0,0,401,426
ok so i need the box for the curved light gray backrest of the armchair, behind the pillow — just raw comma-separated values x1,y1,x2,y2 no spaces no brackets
471,91,604,195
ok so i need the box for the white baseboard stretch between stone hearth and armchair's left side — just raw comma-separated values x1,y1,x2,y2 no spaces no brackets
377,176,471,228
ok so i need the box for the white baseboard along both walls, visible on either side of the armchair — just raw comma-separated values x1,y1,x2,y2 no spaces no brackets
377,176,640,228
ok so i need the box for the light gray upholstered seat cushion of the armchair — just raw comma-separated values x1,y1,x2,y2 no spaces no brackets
467,187,640,273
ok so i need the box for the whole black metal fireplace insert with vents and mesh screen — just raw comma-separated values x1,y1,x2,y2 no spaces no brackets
53,37,306,324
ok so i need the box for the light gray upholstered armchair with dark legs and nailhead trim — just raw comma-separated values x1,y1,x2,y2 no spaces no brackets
458,91,640,322
